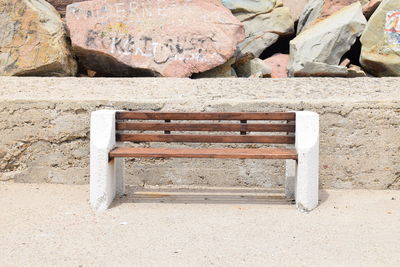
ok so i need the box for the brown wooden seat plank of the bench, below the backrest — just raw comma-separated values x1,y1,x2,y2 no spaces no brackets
109,147,297,159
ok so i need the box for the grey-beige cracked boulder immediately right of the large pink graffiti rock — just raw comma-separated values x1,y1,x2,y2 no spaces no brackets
222,0,294,60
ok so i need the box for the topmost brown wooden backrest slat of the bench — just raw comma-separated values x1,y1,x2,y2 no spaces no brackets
116,112,296,120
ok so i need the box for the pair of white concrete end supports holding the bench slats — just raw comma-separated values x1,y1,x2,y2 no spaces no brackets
90,110,319,211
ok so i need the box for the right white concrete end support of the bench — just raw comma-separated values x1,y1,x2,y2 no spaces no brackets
295,111,319,211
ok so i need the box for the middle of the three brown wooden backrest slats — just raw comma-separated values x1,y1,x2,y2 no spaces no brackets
116,122,295,132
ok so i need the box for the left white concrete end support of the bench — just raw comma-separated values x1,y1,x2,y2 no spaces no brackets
90,110,124,210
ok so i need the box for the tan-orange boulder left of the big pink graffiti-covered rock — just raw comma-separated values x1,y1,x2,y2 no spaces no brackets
0,0,76,76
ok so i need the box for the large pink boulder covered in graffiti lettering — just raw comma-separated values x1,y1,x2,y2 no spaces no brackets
66,0,245,77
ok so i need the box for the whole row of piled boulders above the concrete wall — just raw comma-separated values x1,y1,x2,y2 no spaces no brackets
0,0,400,78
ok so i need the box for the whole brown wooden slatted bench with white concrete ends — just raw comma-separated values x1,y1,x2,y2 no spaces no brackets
90,110,319,211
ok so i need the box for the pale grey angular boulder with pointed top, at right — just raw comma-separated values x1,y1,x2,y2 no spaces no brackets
289,2,367,76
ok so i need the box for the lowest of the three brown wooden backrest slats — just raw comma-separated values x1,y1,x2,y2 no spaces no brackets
116,134,295,144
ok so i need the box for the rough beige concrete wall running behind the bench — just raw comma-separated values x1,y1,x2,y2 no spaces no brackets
0,78,400,189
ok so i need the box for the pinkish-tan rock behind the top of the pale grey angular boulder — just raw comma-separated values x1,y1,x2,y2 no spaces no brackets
297,0,370,34
